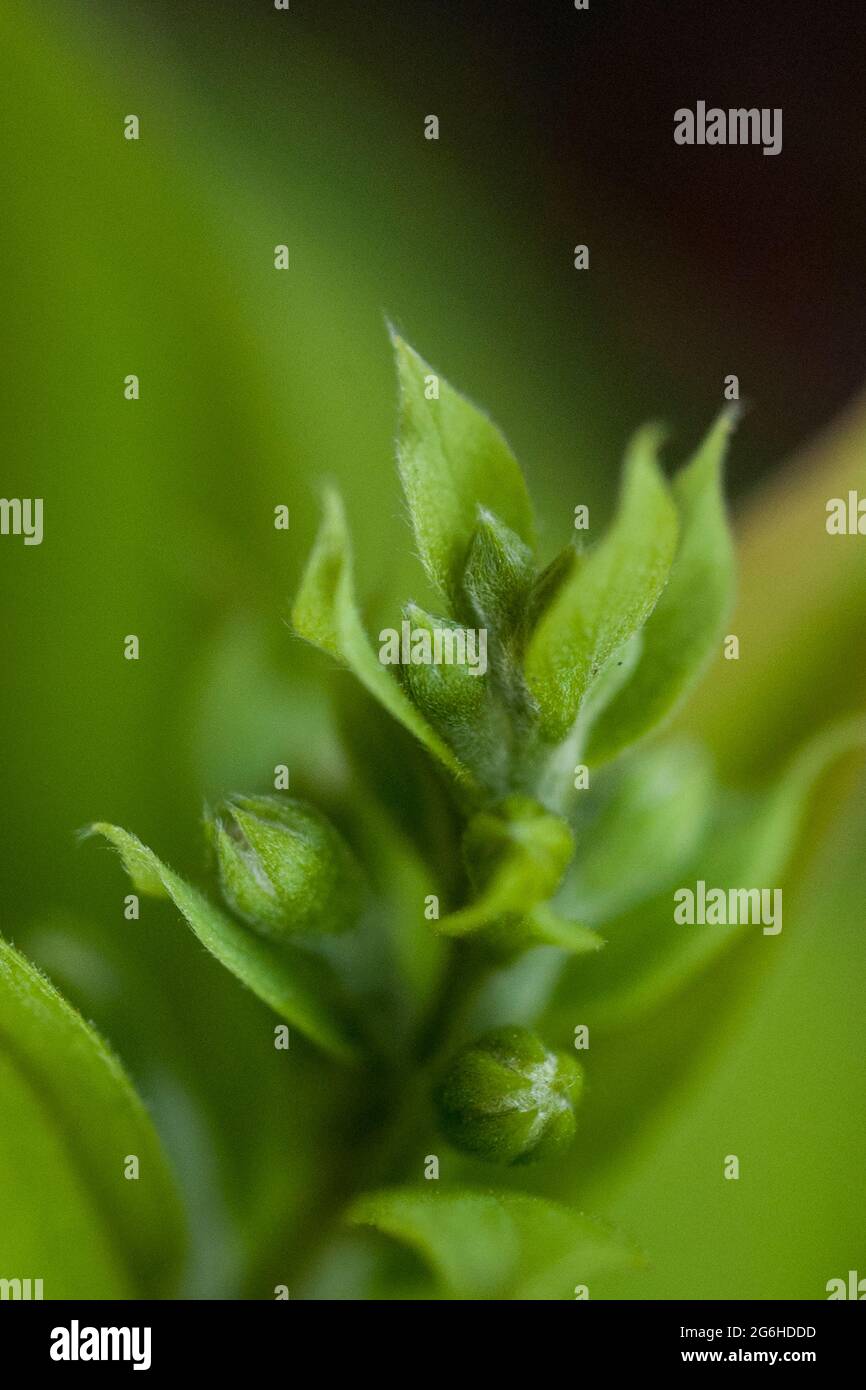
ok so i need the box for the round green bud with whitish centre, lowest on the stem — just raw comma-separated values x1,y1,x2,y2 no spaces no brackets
436,1027,584,1163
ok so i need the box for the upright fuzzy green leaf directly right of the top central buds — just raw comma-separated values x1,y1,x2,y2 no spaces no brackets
525,427,677,741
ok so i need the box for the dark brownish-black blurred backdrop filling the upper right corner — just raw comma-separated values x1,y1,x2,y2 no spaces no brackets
139,0,866,489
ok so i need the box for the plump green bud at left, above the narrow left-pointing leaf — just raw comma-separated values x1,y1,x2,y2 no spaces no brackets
206,796,360,940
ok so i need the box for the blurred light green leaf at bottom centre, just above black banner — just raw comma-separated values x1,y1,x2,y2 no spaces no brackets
348,1187,642,1301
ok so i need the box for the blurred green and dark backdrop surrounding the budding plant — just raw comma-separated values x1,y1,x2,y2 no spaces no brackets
0,0,866,1298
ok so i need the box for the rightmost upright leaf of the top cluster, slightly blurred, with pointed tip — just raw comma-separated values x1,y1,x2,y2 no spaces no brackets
587,410,735,765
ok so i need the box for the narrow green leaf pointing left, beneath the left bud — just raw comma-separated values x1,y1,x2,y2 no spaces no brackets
88,821,354,1062
